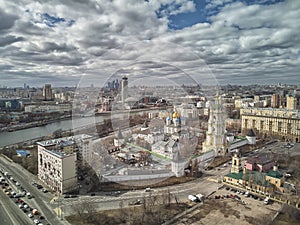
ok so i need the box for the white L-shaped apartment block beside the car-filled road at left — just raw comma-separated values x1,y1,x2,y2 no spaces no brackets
37,135,91,193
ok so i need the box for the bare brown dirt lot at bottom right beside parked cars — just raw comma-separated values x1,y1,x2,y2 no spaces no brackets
174,190,281,225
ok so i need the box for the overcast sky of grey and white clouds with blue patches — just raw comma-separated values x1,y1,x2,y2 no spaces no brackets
0,0,300,87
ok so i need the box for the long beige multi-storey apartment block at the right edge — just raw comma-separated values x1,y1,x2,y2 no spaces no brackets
240,108,300,142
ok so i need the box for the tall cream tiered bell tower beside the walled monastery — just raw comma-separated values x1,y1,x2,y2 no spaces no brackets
202,88,227,155
